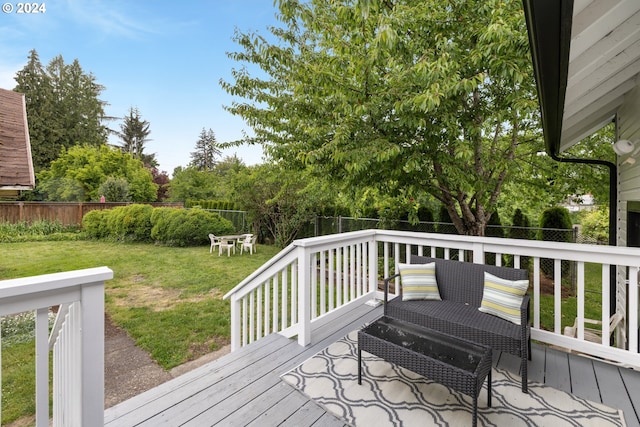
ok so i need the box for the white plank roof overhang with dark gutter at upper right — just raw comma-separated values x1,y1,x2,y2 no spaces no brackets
523,0,640,154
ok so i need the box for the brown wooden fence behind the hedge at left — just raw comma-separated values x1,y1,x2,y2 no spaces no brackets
0,202,184,225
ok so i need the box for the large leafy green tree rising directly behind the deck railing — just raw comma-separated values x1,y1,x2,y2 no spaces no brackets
221,0,538,235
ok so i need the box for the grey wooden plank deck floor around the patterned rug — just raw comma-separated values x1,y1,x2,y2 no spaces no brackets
105,305,640,427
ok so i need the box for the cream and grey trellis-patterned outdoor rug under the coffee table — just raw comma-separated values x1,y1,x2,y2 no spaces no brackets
282,332,626,427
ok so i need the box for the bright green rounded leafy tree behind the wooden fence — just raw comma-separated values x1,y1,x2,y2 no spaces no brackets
37,145,158,202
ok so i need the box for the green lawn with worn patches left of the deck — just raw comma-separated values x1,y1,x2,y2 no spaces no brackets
0,240,279,424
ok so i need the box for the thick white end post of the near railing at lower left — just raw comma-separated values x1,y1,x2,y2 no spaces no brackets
80,282,104,426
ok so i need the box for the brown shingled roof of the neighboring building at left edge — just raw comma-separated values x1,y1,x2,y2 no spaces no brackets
0,89,35,192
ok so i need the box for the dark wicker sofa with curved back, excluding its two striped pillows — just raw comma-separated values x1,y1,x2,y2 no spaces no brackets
384,255,531,393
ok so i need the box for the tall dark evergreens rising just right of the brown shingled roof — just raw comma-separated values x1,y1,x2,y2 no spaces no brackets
14,50,107,172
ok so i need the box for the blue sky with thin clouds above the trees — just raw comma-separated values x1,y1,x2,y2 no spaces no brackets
0,0,278,174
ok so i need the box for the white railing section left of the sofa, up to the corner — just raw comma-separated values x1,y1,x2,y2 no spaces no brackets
224,233,378,350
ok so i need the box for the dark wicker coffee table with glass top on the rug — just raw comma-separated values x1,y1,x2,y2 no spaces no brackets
358,316,491,426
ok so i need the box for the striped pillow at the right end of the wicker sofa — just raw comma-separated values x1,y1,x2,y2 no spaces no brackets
479,271,529,325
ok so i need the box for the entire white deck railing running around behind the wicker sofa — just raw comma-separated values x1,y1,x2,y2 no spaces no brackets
225,230,640,367
